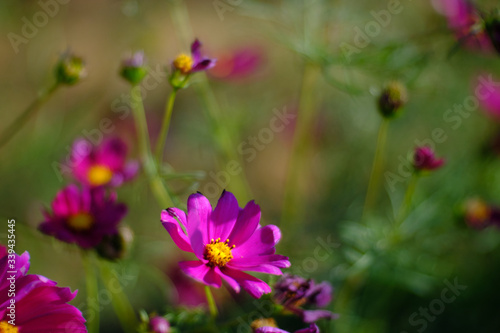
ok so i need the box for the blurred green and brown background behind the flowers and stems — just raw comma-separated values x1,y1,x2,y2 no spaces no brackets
0,0,500,333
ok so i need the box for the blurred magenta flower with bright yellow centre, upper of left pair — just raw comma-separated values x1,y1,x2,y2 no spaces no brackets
71,137,139,187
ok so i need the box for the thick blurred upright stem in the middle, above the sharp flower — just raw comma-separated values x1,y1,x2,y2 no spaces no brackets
281,64,319,226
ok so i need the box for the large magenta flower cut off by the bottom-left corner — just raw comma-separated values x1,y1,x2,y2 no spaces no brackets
0,245,87,333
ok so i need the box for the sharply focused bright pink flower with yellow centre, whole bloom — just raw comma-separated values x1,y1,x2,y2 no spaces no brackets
161,191,290,298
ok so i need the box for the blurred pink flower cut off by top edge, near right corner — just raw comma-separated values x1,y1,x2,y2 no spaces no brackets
434,0,492,52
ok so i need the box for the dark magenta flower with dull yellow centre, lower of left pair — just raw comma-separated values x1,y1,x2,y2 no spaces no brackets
38,185,127,249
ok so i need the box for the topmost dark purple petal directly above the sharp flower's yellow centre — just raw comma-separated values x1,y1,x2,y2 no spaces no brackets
208,191,240,244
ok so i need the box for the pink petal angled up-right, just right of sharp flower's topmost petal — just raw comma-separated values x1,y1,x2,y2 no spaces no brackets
229,200,260,246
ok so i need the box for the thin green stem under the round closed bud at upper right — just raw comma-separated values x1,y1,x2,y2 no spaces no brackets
363,119,389,217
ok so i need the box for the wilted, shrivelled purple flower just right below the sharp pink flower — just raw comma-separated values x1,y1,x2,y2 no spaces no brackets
273,274,338,323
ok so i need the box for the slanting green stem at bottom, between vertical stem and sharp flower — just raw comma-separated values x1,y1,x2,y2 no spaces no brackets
99,260,139,333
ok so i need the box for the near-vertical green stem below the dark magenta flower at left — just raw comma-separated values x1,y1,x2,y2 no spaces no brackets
82,251,100,333
